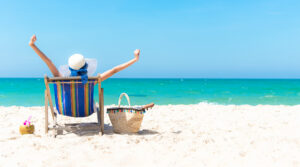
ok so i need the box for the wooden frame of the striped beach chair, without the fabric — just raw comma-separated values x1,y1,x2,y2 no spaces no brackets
44,74,104,136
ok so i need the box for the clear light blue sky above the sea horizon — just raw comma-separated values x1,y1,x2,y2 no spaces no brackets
0,0,300,78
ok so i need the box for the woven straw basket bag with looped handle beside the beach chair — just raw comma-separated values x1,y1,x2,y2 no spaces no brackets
107,93,145,133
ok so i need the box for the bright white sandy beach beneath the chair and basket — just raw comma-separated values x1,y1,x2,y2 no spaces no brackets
0,103,300,167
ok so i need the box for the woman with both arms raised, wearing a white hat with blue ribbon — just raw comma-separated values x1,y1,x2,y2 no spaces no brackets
29,35,140,81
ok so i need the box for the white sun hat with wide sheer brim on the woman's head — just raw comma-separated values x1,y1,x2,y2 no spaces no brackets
59,54,97,77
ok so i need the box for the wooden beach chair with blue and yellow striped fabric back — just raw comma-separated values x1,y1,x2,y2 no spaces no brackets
44,74,104,135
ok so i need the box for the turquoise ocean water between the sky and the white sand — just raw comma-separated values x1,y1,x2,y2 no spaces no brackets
0,78,300,106
